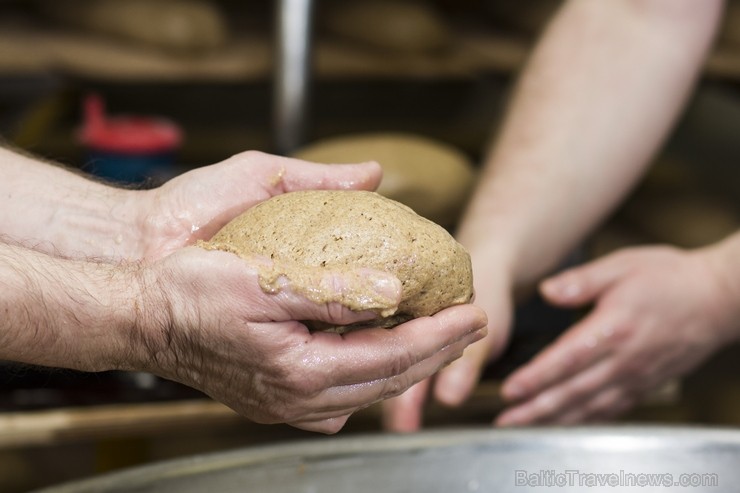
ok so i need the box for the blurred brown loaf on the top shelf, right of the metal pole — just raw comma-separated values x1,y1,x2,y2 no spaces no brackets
319,0,452,53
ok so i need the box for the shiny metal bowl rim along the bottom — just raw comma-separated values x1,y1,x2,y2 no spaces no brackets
33,426,740,493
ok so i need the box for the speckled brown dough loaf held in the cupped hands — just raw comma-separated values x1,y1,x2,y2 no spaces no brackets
199,191,473,332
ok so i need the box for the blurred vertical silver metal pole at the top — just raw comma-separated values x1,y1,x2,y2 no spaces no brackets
273,0,314,154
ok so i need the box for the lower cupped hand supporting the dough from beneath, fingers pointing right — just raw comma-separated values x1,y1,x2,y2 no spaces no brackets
136,247,486,433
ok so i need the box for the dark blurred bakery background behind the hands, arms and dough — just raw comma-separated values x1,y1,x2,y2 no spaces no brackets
0,0,740,493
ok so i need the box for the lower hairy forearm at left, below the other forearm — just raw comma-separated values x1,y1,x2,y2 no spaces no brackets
0,238,137,371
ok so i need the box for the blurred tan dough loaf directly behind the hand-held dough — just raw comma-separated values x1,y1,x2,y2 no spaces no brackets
294,133,475,227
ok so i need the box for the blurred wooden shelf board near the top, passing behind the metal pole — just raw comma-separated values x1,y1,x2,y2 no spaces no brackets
0,26,740,83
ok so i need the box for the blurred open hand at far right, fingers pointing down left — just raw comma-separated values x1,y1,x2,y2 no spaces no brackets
496,247,737,426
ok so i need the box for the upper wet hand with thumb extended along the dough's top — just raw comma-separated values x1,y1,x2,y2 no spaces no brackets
129,151,381,259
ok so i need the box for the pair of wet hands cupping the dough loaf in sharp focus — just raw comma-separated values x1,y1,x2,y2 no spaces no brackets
111,152,486,433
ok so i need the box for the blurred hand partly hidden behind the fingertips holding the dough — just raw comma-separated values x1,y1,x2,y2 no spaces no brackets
383,263,513,433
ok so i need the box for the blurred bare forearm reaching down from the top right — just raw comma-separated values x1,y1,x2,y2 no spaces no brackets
458,0,722,284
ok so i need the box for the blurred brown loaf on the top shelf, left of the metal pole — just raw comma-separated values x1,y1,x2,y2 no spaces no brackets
43,0,227,53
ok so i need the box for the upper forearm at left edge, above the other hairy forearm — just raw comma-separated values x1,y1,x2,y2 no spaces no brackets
0,148,142,258
